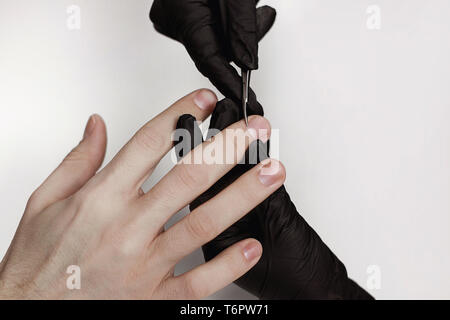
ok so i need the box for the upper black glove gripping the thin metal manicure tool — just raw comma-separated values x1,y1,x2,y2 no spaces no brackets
150,0,276,115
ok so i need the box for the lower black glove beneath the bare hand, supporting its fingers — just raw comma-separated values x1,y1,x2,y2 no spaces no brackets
172,99,373,299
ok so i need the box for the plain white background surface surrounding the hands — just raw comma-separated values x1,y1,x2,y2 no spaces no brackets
0,0,450,299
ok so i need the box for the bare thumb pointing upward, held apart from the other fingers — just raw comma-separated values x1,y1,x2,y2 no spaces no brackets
27,115,106,212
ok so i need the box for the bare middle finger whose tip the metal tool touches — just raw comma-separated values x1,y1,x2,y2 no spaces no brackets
140,116,270,227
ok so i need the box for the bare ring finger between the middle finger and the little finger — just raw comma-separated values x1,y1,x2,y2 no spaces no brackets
155,159,286,268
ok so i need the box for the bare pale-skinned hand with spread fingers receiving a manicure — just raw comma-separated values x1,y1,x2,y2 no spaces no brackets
0,89,285,299
